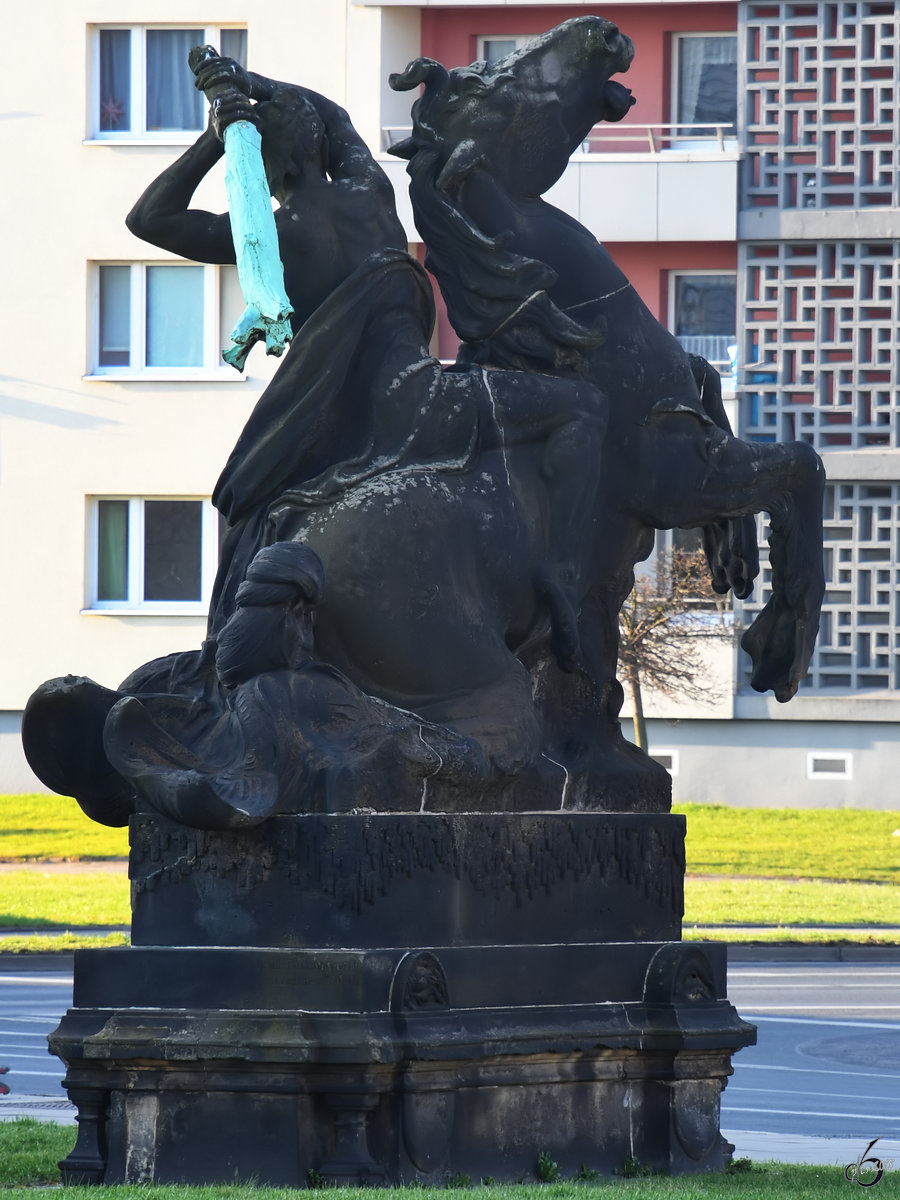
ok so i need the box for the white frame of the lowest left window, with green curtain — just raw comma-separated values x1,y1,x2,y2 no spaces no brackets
82,493,220,618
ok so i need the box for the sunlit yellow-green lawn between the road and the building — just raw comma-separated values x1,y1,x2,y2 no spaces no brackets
0,796,900,952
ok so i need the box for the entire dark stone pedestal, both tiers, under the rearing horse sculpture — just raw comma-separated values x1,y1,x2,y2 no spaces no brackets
50,814,754,1186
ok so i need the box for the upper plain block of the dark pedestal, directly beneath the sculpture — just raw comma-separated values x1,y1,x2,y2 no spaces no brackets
130,812,684,948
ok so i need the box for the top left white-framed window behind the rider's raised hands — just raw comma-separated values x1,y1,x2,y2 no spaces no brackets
89,25,247,140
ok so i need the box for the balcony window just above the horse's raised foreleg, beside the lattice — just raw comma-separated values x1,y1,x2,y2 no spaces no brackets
668,271,738,374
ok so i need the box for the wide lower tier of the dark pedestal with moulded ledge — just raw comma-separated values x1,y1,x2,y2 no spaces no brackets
50,943,754,1186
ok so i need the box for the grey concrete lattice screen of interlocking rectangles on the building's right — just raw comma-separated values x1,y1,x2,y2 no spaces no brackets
738,0,900,691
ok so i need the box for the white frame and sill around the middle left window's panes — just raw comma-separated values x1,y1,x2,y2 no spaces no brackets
84,258,236,382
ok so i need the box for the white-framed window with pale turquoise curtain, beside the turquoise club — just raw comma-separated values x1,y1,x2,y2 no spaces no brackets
90,262,236,378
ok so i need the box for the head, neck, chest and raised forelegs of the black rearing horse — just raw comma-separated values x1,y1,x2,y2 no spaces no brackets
391,17,824,701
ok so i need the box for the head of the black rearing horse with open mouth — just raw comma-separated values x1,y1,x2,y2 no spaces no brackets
390,17,634,196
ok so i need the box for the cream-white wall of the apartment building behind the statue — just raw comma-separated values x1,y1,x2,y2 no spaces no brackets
0,0,900,808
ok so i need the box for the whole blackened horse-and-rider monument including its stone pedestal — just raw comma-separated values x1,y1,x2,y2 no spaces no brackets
31,17,823,1186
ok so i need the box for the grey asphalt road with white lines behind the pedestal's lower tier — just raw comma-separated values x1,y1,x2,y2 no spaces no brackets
0,962,900,1166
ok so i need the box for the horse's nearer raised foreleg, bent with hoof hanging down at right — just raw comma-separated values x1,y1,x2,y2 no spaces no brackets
644,416,824,703
